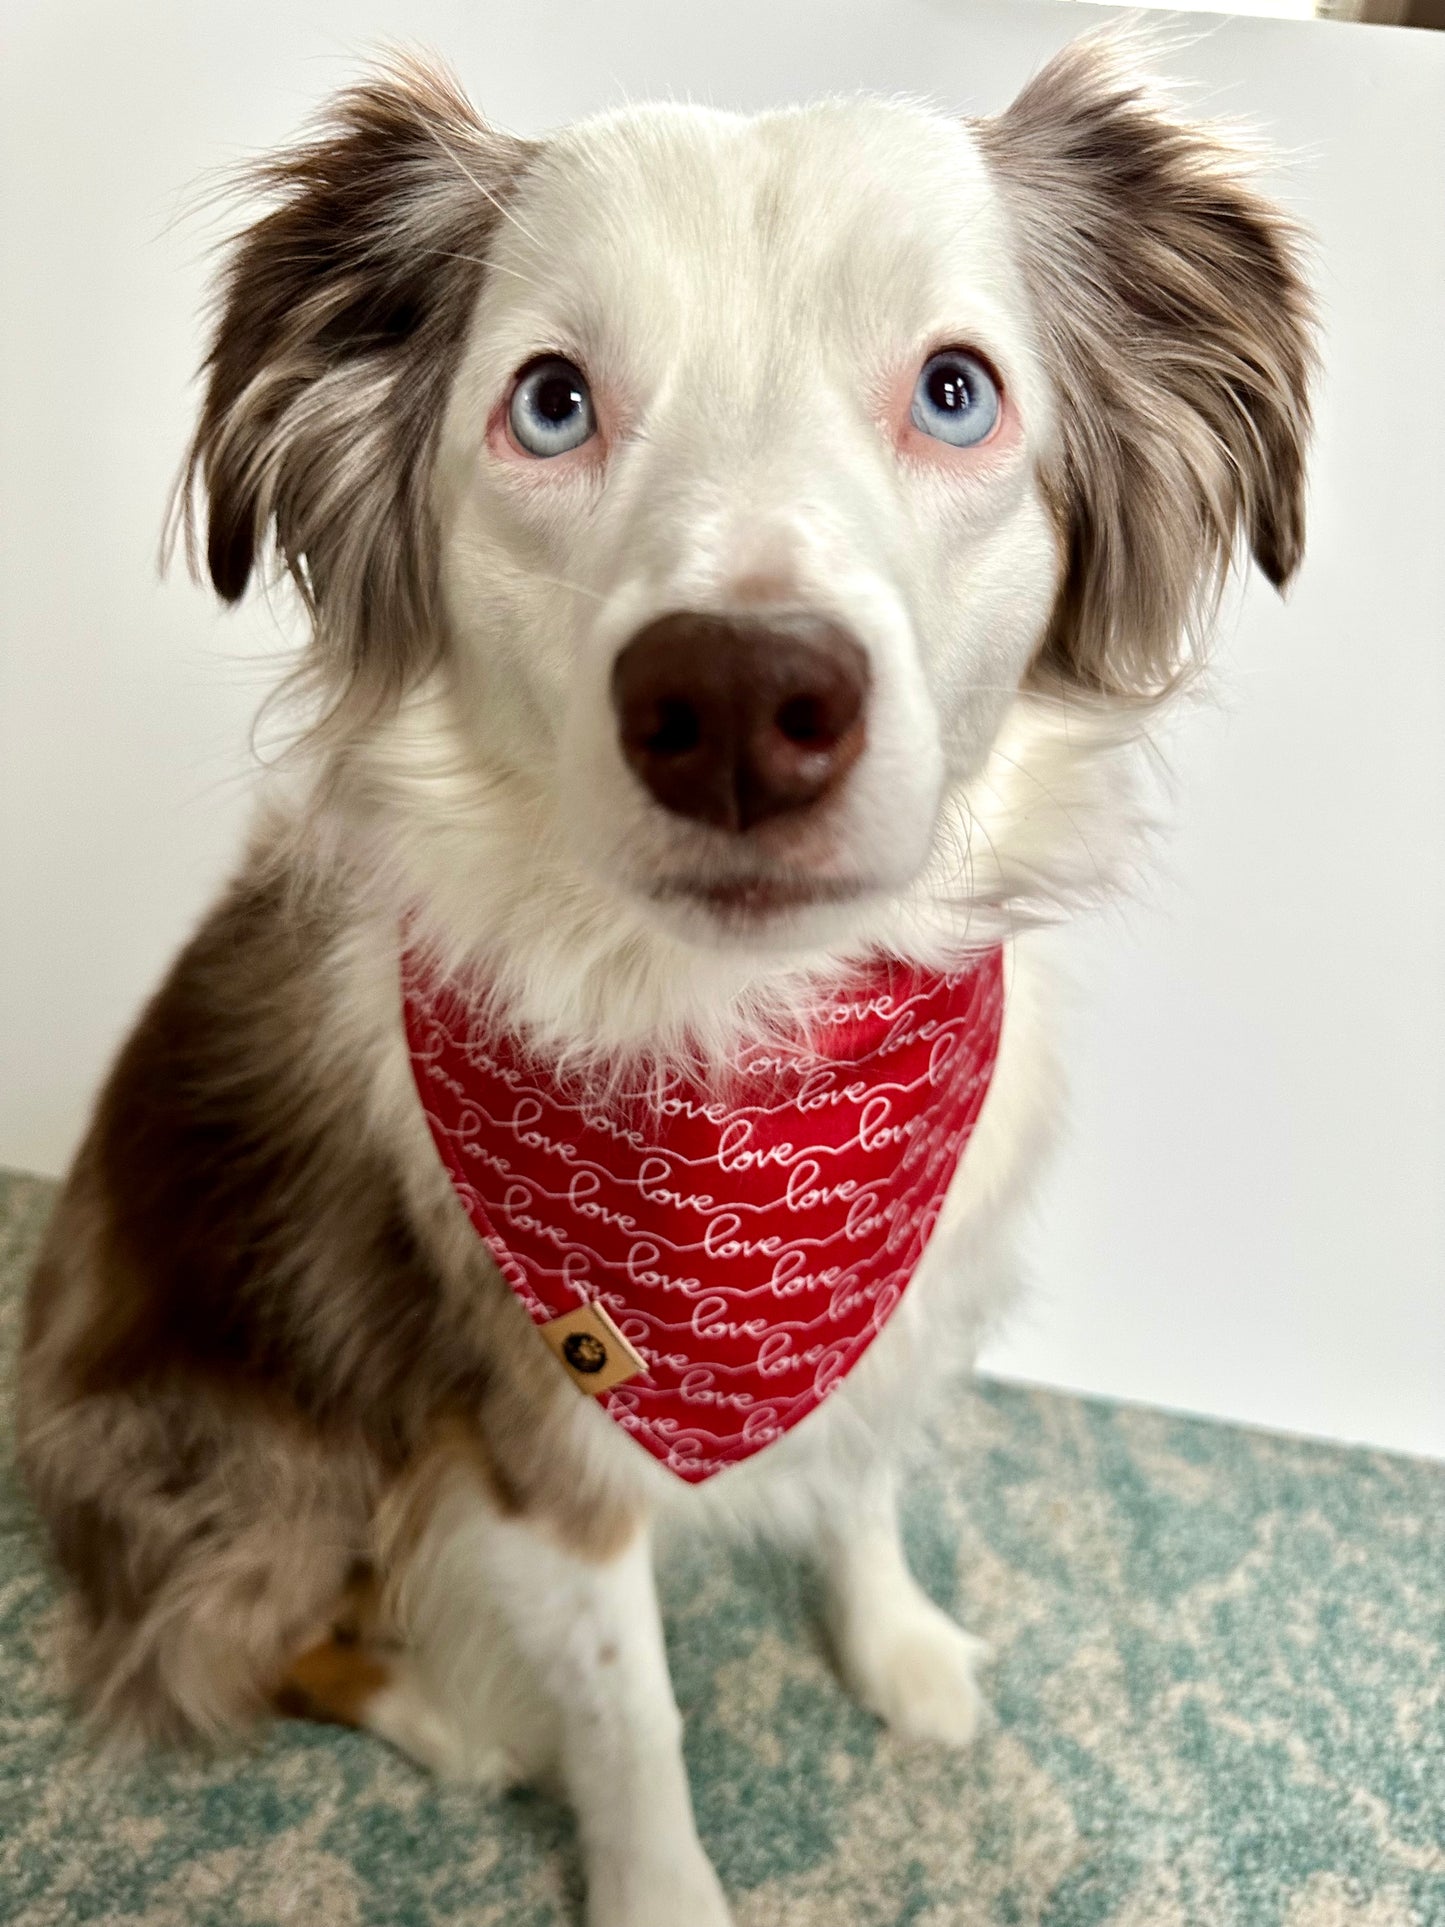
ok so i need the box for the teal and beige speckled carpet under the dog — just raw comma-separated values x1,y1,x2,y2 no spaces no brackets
0,1177,1445,1927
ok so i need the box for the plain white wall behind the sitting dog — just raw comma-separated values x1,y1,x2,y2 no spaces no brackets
0,0,1445,1453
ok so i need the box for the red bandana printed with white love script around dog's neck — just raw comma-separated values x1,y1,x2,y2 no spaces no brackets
403,950,1004,1482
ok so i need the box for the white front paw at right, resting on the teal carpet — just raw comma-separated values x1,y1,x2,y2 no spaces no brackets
844,1601,988,1746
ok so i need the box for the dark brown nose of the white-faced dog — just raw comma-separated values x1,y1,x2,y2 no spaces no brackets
613,613,869,831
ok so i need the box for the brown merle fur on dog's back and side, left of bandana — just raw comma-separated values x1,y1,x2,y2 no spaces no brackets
19,828,636,1738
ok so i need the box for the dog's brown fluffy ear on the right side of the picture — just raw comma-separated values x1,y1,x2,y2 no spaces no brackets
977,29,1314,700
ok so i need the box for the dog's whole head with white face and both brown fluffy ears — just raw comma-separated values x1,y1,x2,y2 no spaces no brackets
178,37,1310,986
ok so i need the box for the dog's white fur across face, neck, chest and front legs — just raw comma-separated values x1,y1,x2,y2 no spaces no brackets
285,104,1139,1927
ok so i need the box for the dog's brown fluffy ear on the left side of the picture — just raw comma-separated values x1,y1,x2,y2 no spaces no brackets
181,56,530,724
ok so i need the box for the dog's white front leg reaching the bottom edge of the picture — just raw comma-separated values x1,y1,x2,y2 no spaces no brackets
487,1518,730,1927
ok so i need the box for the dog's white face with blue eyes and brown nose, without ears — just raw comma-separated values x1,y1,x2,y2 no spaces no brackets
437,102,1062,942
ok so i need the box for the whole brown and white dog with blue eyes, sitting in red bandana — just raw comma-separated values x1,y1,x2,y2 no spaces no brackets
19,37,1314,1927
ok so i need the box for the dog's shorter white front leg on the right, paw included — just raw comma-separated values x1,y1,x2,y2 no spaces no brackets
819,1466,986,1746
